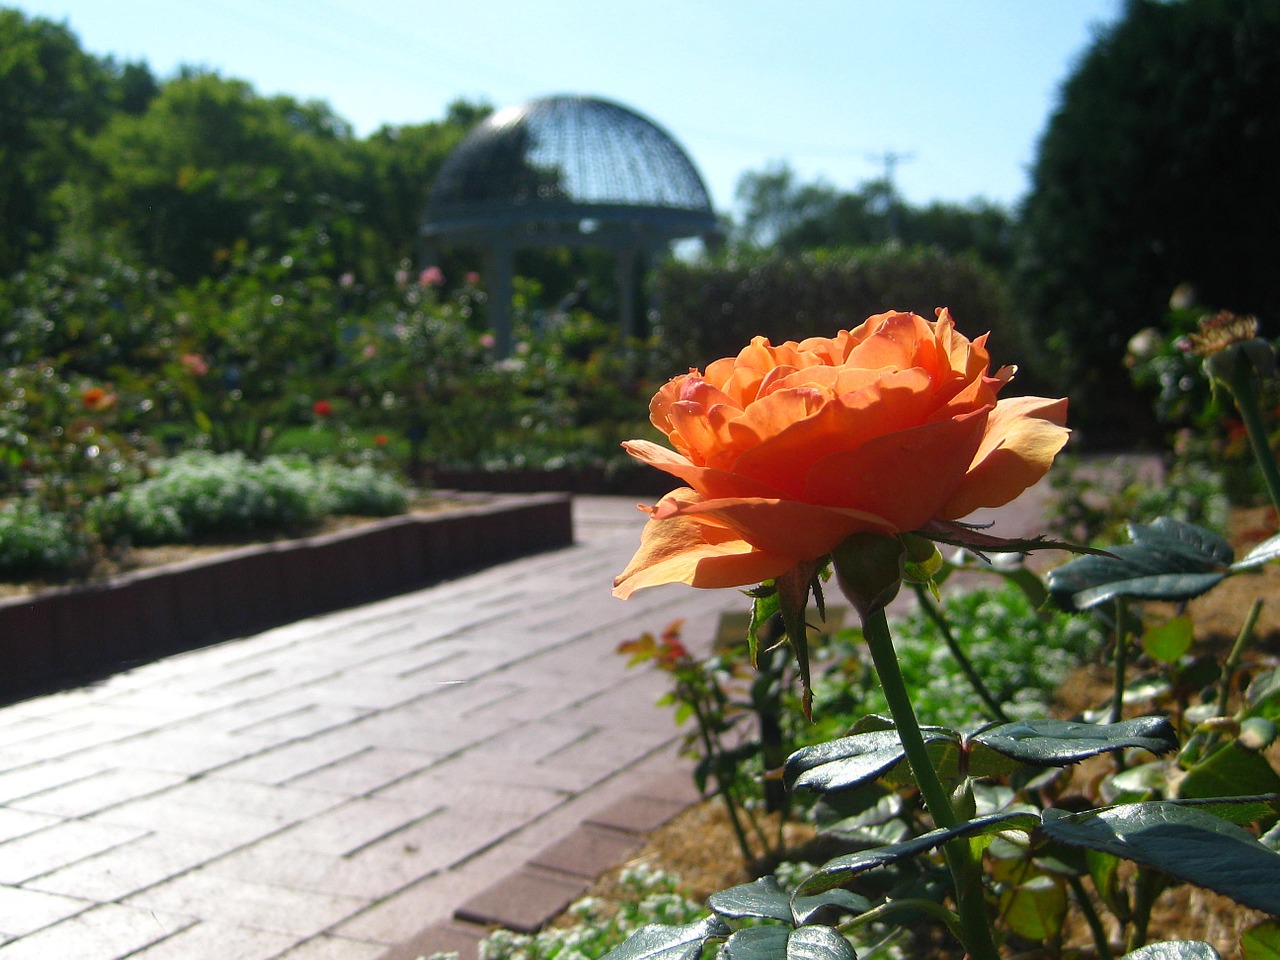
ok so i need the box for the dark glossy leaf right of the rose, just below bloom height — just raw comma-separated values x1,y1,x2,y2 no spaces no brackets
1048,517,1235,611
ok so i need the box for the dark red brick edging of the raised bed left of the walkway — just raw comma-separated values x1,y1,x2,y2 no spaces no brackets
0,493,573,703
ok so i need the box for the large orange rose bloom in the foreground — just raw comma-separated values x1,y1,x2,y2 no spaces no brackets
613,310,1068,599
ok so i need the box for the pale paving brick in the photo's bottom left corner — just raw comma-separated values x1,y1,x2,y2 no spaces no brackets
0,904,193,960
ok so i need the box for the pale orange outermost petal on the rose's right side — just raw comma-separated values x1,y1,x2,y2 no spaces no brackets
937,397,1070,520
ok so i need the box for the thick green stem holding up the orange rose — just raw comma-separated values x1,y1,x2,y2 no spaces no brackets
863,607,1000,960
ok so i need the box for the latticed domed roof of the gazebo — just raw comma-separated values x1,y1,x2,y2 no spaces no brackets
424,96,716,237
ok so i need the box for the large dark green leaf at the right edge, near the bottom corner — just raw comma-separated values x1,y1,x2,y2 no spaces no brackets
1043,800,1280,914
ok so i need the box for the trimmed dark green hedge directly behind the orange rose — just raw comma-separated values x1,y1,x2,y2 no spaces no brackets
658,247,1021,376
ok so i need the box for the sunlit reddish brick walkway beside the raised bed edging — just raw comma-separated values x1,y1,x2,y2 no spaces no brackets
0,492,1064,960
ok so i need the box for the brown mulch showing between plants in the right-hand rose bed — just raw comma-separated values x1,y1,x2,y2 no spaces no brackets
576,511,1280,960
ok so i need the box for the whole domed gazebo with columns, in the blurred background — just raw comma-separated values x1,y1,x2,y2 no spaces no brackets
421,96,719,356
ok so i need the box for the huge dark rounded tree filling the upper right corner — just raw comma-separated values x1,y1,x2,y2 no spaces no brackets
1018,0,1280,435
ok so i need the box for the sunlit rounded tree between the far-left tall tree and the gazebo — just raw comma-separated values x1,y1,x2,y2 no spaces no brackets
81,70,357,282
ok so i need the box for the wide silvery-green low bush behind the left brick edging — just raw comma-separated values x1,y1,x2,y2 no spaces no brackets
91,453,408,544
